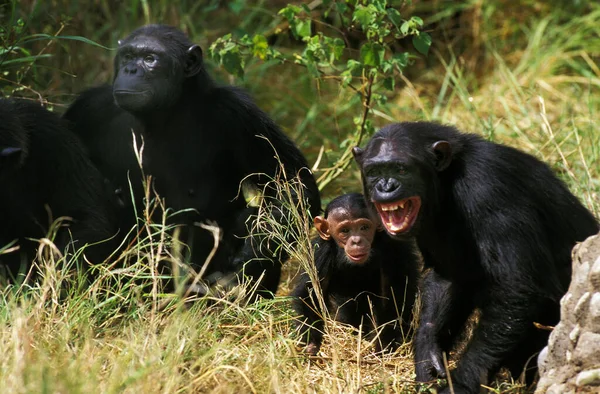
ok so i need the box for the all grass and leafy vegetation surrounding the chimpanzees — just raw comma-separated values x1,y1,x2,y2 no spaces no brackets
0,0,600,393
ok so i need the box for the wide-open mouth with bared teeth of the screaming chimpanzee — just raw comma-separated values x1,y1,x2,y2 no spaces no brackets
374,196,421,235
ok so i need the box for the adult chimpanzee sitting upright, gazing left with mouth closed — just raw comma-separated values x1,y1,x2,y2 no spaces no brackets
64,25,320,296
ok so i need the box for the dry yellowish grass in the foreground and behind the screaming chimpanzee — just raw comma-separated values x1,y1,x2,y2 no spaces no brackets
0,1,600,393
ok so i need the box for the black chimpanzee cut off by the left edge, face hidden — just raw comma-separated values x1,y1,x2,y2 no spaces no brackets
0,99,117,279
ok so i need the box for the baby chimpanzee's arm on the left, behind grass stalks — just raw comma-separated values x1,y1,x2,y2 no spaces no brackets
292,239,337,355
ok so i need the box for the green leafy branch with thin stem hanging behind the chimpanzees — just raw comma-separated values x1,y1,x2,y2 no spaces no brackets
209,0,431,189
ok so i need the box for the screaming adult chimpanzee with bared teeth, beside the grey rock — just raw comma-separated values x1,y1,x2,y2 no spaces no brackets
354,122,598,393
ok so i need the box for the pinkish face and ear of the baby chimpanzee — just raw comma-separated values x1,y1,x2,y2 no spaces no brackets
314,207,376,264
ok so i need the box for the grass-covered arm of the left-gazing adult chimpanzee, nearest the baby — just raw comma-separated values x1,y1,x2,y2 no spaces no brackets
229,88,321,296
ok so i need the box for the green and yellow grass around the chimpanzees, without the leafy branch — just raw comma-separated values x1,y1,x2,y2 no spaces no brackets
0,0,600,393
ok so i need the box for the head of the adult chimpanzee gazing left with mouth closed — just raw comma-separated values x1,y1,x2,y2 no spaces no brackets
113,34,202,113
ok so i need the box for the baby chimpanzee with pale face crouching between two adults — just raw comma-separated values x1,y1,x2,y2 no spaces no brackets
292,193,419,355
